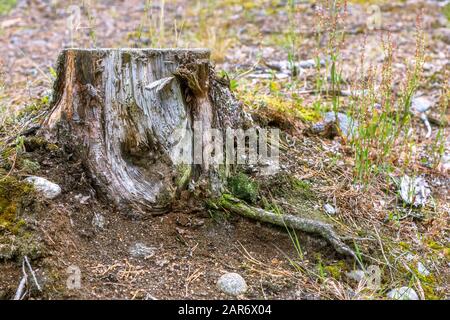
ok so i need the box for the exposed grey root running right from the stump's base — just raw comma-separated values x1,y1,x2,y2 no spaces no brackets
218,194,361,264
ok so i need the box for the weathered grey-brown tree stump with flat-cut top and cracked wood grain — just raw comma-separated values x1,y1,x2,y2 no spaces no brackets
43,49,248,212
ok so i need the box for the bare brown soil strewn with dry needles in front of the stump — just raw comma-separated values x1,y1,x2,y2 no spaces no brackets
1,139,344,299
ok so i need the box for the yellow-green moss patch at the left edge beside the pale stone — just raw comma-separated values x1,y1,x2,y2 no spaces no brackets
0,176,33,234
